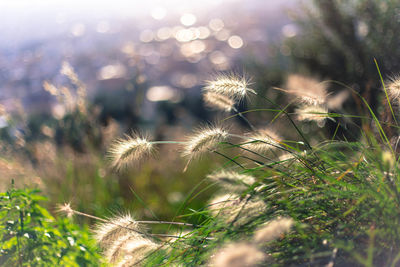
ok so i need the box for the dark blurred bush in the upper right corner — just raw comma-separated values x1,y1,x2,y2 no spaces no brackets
286,0,400,138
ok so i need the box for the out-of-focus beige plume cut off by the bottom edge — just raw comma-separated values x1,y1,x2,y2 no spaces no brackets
209,243,266,267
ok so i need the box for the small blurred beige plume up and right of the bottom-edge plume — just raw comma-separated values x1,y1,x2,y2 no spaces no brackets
254,218,293,243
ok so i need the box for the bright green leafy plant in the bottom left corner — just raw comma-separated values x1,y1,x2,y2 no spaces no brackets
0,188,102,266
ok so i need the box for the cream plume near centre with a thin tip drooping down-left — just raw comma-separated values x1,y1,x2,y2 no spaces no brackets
182,126,229,171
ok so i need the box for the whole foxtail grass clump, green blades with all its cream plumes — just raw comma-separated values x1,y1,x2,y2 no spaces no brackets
55,73,400,266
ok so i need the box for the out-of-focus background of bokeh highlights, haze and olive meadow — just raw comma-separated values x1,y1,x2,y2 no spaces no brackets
0,0,400,226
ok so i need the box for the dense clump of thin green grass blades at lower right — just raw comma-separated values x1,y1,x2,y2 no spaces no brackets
148,141,400,266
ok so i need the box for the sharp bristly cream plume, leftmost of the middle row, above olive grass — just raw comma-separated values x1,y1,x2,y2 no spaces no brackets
108,134,154,170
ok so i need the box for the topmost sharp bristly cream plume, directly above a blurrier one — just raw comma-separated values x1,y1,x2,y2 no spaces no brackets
203,75,255,100
